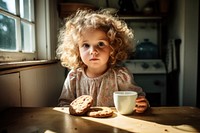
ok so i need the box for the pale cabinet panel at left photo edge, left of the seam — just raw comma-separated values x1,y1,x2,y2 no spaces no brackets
0,73,21,110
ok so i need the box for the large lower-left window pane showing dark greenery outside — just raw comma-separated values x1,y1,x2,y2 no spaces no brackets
0,14,16,50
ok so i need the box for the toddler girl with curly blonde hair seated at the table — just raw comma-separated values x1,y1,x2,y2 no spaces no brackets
57,10,148,113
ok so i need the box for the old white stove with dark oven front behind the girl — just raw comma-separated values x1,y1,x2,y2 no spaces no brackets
124,59,167,106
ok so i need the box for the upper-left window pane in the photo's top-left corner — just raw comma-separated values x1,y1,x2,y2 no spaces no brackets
0,0,16,14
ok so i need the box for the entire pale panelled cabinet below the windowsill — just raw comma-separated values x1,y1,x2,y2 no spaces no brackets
0,62,65,110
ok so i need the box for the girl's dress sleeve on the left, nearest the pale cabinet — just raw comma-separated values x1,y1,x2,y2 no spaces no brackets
58,70,76,106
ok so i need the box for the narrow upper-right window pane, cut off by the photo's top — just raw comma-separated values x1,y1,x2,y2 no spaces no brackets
20,0,32,21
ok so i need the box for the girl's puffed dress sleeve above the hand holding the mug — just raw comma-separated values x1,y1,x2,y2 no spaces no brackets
117,67,145,96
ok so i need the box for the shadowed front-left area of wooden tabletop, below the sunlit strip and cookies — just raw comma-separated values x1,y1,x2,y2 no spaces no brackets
0,108,134,133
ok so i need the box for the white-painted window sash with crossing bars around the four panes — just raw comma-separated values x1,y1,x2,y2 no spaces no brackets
0,0,37,62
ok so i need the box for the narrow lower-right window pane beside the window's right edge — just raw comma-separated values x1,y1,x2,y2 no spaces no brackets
21,22,35,52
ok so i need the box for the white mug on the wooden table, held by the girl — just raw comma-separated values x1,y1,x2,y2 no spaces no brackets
113,91,138,115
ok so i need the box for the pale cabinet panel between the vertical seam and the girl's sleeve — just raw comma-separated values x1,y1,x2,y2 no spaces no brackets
20,64,65,107
